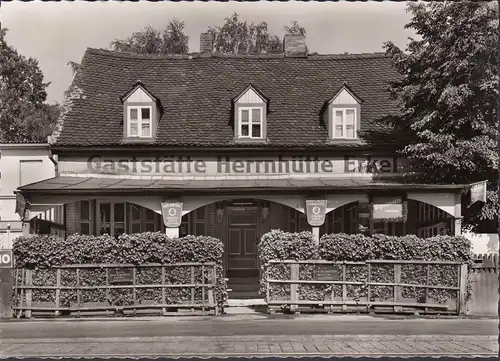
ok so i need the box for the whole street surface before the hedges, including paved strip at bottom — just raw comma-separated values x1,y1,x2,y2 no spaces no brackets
0,315,498,357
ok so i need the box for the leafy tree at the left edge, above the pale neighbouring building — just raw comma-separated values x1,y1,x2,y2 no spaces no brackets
0,29,58,142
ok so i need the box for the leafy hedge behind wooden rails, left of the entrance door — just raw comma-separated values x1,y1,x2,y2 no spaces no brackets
13,232,227,307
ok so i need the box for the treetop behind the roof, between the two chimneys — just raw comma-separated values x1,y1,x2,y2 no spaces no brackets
208,13,306,54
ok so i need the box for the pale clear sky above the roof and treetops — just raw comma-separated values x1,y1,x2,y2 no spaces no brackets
0,1,414,103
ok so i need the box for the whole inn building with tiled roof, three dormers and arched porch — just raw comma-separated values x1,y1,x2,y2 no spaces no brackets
18,34,484,296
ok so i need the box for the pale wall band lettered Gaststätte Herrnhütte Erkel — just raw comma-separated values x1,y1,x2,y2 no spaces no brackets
59,155,406,176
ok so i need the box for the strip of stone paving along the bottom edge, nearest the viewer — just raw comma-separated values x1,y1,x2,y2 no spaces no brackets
0,335,498,358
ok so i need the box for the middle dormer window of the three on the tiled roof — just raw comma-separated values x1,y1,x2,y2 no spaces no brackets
233,84,269,142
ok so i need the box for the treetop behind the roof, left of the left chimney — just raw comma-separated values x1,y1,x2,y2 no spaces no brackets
111,19,189,54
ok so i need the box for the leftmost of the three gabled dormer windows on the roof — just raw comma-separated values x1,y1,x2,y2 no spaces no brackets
121,82,161,142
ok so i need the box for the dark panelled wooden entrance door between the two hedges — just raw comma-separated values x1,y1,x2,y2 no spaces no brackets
228,207,258,277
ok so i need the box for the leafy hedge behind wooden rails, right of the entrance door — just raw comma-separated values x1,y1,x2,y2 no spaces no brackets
259,231,474,303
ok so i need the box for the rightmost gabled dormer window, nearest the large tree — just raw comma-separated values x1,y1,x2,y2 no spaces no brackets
325,83,361,141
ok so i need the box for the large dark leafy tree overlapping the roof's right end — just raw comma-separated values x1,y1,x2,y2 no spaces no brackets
385,1,499,231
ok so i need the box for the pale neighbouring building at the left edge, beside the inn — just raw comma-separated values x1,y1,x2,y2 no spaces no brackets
0,143,64,249
